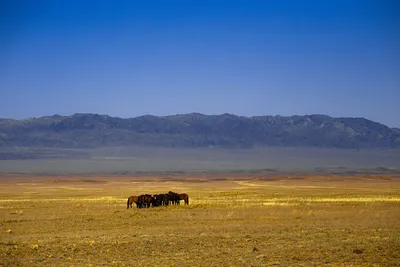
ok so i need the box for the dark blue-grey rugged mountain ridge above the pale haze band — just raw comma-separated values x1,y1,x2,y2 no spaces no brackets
0,113,400,148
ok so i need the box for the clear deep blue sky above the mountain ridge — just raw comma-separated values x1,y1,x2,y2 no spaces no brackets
0,0,400,127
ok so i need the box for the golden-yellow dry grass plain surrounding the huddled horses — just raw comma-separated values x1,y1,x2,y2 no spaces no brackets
0,174,400,266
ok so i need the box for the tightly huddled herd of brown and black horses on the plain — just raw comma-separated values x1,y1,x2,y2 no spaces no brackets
126,191,189,209
